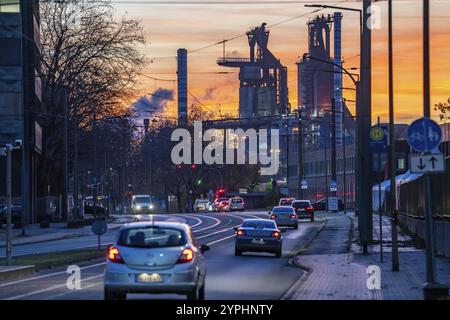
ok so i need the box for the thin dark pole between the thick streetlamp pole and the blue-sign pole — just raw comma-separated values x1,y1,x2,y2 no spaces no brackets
388,0,400,271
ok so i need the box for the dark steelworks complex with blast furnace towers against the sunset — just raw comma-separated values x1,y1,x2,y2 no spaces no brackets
177,12,355,200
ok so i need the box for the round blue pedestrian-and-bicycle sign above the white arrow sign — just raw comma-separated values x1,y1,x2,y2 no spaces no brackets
408,118,442,152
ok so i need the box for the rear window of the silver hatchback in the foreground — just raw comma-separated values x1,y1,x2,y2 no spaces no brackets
118,227,186,248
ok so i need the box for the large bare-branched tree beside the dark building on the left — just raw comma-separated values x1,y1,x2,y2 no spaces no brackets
40,0,147,195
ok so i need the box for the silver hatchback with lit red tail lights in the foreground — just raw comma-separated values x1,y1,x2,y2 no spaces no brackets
104,221,209,300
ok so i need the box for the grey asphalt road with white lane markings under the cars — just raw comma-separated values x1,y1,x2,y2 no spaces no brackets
0,212,323,300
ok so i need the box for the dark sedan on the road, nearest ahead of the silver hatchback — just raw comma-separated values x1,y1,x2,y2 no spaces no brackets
234,219,283,258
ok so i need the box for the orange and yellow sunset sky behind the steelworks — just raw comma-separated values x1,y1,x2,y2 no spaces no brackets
112,0,450,123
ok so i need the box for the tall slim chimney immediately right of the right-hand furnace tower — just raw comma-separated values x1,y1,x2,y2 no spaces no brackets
333,12,344,146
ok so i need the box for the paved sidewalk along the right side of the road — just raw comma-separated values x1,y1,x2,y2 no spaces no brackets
285,213,450,300
